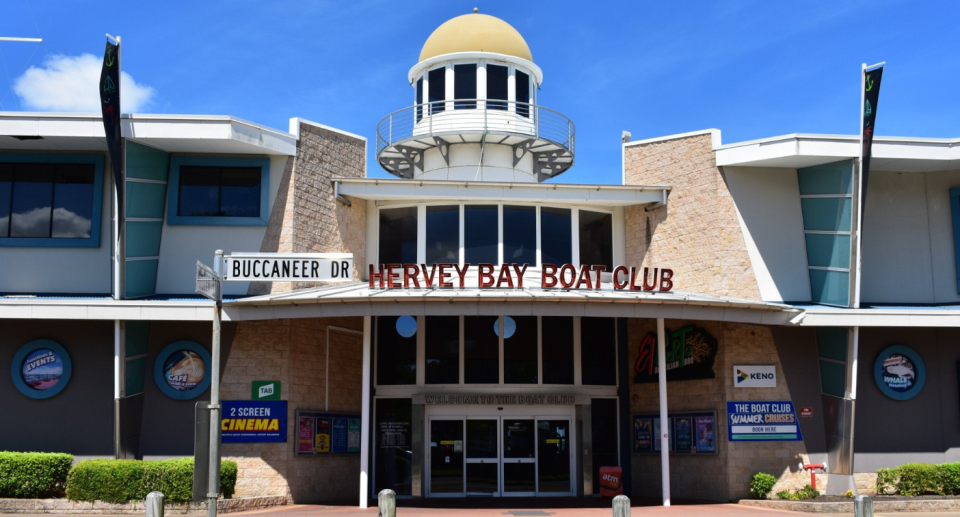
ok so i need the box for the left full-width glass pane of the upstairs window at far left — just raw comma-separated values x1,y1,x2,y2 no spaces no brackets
10,163,56,238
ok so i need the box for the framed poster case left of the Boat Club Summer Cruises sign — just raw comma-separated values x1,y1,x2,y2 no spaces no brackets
633,411,717,454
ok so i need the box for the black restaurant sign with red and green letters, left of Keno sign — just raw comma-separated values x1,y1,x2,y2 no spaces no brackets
633,325,717,384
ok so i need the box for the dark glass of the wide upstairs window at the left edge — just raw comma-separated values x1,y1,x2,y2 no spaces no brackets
0,163,99,239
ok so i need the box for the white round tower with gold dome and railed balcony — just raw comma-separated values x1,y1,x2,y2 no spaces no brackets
377,9,576,182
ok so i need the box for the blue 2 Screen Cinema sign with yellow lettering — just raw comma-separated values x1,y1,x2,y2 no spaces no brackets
220,400,287,443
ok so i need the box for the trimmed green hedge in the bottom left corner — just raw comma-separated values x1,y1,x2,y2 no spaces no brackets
0,452,73,499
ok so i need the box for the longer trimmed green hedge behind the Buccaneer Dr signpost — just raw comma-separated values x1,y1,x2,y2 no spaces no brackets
67,458,237,503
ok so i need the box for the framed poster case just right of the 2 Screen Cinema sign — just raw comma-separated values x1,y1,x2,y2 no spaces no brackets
296,411,360,456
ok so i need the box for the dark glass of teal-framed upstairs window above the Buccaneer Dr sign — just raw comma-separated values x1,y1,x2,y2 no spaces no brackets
177,166,262,217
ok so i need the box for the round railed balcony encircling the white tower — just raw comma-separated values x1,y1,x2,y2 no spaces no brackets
377,99,576,181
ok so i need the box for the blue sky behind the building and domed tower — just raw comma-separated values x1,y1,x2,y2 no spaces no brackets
0,0,960,183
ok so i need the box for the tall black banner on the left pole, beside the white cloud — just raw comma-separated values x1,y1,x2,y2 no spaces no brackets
100,41,124,239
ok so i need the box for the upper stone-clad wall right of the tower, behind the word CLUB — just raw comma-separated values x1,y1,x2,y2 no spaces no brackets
623,134,760,300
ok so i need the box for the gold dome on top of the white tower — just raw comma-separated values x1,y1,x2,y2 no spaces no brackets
420,12,533,62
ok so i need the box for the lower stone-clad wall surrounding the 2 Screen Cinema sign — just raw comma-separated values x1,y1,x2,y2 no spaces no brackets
222,318,363,503
